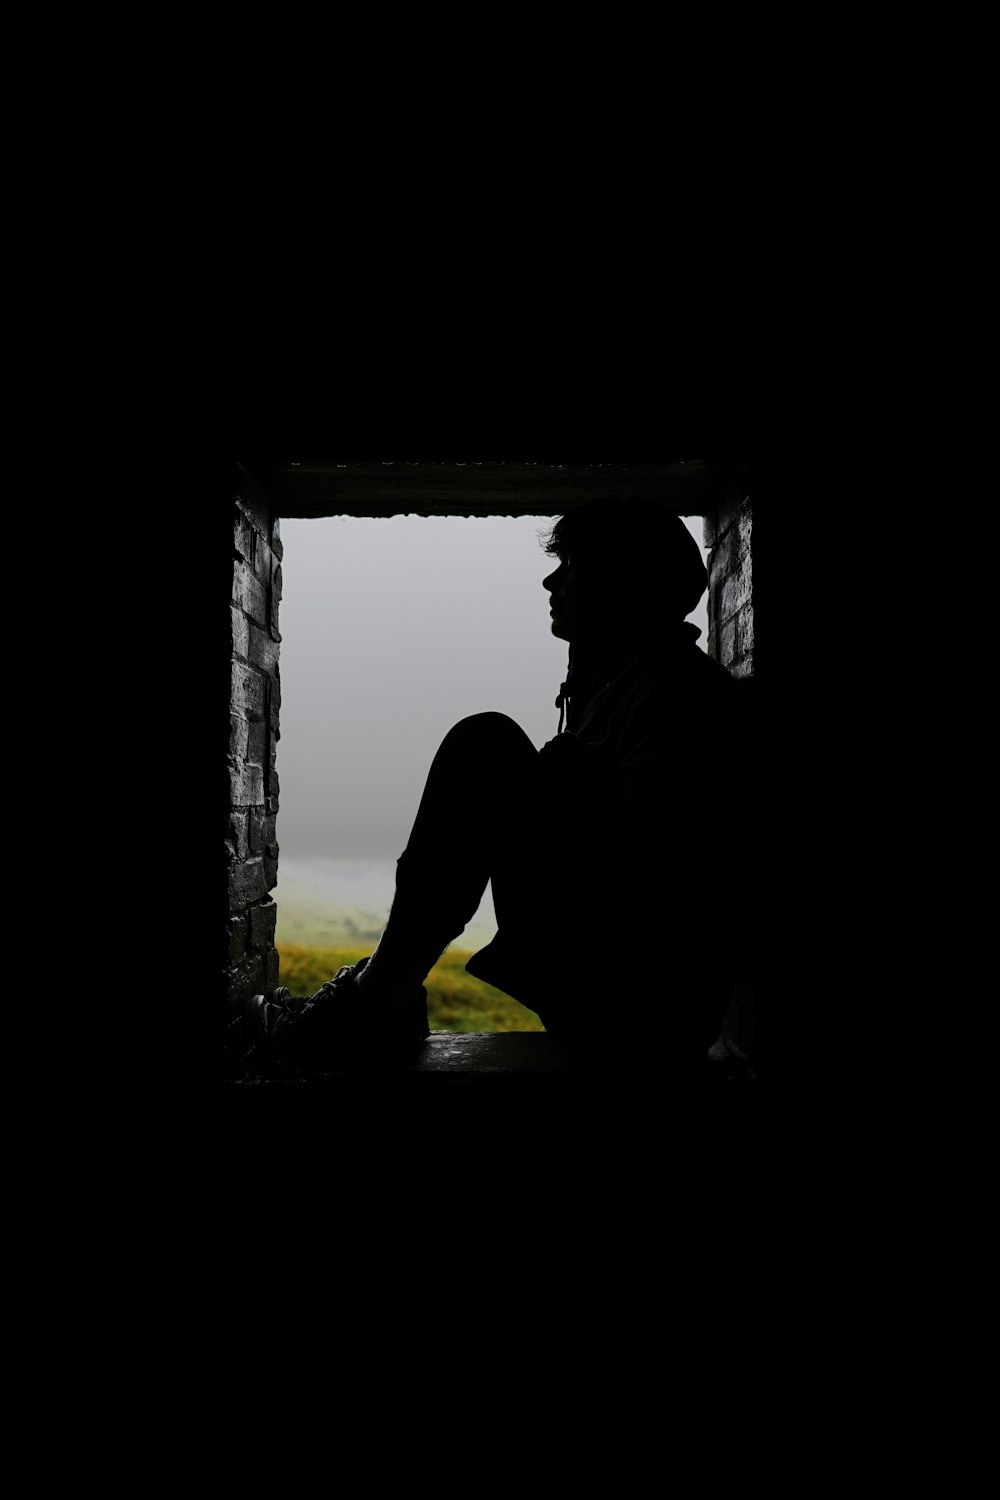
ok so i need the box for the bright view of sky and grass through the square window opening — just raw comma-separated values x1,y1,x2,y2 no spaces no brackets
273,516,708,1031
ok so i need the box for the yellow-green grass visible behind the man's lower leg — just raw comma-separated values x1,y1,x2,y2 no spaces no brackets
276,942,544,1032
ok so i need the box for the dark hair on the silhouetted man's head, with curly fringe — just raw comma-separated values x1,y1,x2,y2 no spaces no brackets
543,495,708,618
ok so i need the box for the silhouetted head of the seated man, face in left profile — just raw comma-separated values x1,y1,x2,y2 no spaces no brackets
543,498,708,642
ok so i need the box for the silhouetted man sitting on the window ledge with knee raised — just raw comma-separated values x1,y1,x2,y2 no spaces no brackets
244,498,736,1079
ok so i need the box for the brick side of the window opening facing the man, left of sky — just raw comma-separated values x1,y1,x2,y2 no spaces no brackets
225,468,282,1010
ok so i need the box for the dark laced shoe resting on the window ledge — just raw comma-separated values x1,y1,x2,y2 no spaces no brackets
243,959,430,1068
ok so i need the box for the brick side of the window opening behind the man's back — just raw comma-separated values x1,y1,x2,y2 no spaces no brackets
705,470,763,1068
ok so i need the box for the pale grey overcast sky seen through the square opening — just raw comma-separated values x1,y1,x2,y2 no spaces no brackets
277,516,708,860
